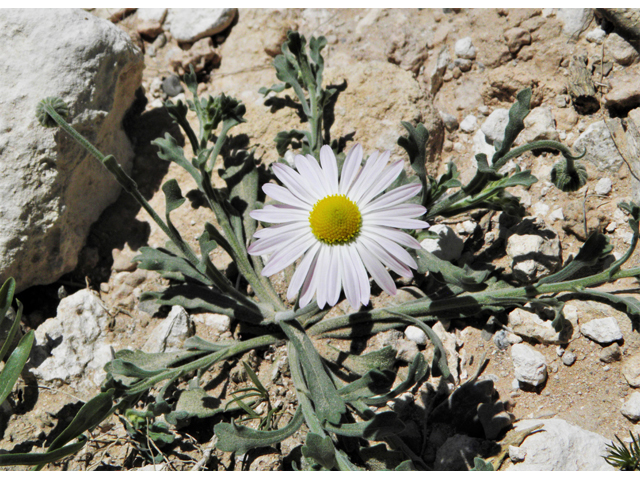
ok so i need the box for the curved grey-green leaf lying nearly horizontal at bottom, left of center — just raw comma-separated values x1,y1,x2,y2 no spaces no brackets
213,408,304,455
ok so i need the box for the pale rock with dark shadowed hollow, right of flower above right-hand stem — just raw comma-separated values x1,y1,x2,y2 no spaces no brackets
507,234,562,281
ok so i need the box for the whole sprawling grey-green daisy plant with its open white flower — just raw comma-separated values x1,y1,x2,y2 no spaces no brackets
31,32,640,470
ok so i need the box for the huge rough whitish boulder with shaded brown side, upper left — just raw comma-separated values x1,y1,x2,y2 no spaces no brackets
0,10,143,290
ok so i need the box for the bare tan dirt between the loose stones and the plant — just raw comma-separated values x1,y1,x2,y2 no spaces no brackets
0,9,640,470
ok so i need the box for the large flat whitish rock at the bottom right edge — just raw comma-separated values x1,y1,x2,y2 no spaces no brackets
507,418,614,471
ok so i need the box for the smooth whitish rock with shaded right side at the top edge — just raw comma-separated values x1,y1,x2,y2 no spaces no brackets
165,8,238,42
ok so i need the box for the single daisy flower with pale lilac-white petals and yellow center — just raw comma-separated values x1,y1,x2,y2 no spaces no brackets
248,144,429,308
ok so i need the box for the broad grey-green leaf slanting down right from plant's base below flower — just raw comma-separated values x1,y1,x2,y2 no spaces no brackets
279,320,347,424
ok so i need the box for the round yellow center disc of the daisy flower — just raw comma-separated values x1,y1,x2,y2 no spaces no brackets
309,195,362,245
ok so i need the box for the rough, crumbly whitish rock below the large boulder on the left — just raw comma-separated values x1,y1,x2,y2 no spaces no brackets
31,290,113,389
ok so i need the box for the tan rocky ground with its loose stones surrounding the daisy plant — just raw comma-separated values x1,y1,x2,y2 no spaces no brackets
0,9,640,470
